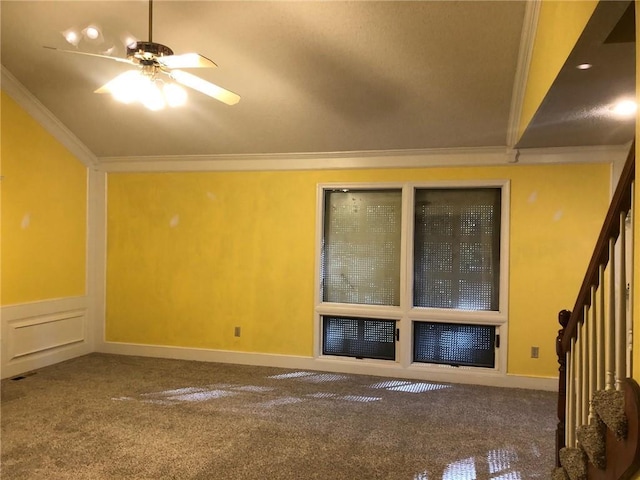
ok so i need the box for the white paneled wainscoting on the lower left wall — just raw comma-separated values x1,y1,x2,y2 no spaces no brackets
0,297,93,378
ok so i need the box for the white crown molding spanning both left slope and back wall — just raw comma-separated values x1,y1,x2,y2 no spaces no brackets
0,62,629,172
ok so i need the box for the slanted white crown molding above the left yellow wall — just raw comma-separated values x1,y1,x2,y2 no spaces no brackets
0,66,98,167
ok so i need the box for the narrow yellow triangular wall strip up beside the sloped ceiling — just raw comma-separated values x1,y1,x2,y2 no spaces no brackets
518,0,598,139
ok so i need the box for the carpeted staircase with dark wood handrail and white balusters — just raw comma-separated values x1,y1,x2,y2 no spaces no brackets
552,142,640,480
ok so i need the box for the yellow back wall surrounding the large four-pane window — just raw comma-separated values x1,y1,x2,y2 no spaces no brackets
106,164,610,376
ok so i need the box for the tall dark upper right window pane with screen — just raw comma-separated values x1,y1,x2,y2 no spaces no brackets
413,188,501,311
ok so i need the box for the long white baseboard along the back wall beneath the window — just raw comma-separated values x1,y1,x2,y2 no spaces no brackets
97,342,558,391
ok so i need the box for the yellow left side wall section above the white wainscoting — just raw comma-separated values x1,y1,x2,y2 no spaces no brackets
0,92,87,305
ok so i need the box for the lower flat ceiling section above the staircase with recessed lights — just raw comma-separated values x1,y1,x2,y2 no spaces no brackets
518,2,635,148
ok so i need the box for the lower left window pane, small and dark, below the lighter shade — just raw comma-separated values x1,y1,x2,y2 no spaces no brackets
322,316,396,360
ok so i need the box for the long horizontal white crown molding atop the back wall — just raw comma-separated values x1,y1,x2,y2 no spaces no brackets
99,145,628,173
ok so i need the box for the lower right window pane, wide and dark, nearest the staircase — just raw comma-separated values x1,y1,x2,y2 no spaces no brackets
413,322,496,368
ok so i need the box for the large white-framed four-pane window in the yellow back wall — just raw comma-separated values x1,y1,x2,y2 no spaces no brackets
316,181,508,369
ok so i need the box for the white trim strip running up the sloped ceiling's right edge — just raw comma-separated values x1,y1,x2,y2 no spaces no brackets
507,0,541,147
